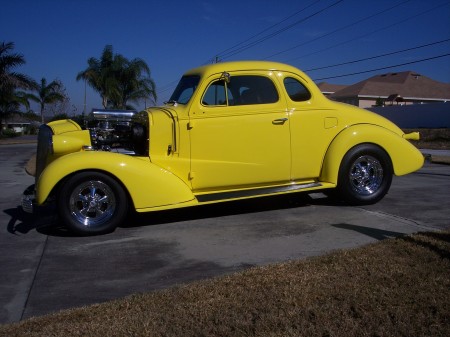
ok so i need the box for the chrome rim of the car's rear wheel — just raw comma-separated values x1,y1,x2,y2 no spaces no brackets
349,155,383,195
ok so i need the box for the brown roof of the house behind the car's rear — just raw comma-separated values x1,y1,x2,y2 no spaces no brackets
330,71,450,100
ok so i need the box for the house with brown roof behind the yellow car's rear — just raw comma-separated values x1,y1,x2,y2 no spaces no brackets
318,71,450,108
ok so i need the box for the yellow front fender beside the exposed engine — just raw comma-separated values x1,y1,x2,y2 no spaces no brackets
36,151,195,210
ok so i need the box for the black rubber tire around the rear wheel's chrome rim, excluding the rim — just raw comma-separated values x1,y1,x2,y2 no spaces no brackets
337,144,393,205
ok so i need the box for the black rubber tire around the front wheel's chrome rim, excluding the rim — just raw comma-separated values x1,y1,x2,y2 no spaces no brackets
57,171,128,235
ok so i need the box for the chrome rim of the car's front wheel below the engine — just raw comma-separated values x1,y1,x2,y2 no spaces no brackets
69,181,116,227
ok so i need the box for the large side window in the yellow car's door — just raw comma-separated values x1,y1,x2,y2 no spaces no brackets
202,76,278,106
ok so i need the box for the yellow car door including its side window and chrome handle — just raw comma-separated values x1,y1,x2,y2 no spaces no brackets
189,74,291,192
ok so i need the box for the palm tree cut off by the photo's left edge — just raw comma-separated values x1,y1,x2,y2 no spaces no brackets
0,42,36,131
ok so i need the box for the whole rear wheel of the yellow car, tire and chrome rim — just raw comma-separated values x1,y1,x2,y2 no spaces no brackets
337,144,393,205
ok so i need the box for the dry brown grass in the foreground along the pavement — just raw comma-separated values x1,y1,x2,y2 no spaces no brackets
0,232,450,337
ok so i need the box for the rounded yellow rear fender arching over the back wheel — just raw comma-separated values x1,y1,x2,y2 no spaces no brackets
320,124,424,184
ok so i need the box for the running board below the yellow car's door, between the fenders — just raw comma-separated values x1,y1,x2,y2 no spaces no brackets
196,183,322,202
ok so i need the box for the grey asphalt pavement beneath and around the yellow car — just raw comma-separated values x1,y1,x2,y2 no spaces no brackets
0,144,450,323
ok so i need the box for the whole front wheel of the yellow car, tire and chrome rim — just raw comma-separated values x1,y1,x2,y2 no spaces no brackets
57,171,128,235
